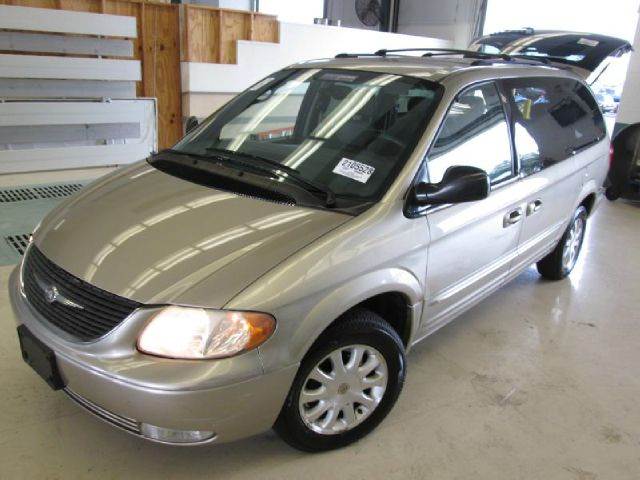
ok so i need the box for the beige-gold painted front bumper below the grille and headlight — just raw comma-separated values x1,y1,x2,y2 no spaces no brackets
9,268,297,444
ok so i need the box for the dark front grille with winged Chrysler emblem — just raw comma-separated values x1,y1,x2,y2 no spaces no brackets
23,245,142,342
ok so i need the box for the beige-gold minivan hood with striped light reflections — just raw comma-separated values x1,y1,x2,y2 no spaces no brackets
34,163,351,308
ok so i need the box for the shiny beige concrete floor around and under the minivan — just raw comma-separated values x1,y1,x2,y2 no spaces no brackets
0,173,640,480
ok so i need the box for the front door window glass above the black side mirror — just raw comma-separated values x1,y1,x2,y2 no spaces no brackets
427,82,513,185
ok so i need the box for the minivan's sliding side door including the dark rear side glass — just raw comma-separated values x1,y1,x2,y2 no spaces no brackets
500,77,606,274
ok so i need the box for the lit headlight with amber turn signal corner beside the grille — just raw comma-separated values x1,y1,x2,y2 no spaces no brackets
138,306,276,359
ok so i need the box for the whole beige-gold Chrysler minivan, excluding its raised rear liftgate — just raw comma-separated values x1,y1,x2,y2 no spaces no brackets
10,50,609,451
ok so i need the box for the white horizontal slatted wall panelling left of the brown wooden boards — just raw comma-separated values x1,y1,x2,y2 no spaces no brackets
0,4,157,174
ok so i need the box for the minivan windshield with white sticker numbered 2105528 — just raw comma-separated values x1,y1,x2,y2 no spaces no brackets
171,68,442,202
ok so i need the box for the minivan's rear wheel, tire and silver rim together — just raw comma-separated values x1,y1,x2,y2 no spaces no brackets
536,205,587,280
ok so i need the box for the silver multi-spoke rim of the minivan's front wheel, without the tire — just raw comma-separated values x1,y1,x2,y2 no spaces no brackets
298,345,388,435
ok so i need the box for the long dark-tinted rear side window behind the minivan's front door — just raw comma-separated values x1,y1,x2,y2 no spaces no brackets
503,78,606,176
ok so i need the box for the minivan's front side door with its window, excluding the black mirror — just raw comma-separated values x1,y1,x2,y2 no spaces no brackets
422,82,526,334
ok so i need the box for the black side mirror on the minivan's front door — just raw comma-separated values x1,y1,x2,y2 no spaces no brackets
412,166,491,206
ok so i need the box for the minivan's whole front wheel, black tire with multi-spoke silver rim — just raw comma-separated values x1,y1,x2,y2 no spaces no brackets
274,309,406,452
